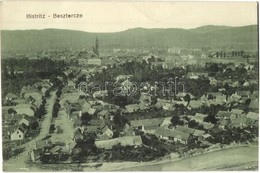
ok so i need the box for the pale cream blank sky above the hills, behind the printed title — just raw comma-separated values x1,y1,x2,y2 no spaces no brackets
0,0,257,32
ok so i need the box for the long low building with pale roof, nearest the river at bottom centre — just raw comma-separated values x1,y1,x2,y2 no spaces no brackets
95,136,142,149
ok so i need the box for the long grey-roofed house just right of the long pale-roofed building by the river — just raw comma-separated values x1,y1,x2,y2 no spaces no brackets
155,127,192,144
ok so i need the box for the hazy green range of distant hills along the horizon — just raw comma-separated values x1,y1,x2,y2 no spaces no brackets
1,25,258,51
